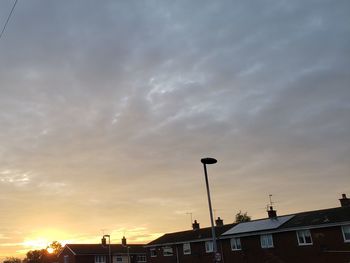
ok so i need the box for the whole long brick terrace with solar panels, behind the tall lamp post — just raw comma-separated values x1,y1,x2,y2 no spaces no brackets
146,194,350,263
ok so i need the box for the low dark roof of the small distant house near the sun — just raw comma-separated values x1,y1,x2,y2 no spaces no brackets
65,244,145,255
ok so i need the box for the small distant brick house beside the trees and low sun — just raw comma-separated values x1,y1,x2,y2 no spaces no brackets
58,244,147,263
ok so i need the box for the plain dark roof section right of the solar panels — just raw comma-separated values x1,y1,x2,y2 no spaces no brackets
281,207,350,229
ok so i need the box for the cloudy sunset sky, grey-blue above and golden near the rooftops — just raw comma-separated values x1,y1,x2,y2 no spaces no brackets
0,0,350,258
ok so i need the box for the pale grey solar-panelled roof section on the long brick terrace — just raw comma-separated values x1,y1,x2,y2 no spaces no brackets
222,215,294,236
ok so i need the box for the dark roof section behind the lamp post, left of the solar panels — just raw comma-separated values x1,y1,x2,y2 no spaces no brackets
147,224,236,246
